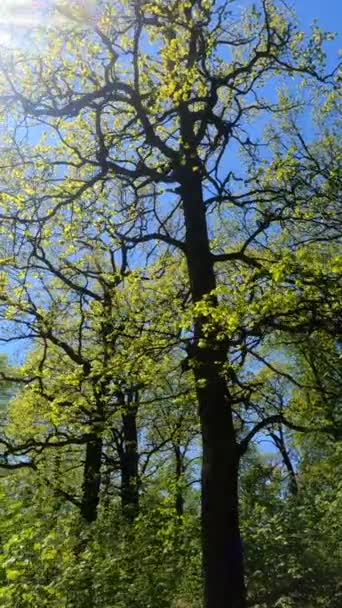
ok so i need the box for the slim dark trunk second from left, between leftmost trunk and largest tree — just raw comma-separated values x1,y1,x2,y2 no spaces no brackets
120,393,139,520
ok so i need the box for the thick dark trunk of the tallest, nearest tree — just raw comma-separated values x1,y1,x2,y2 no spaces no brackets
180,169,246,608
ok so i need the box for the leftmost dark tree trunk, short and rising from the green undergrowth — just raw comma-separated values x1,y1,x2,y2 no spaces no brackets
81,433,102,523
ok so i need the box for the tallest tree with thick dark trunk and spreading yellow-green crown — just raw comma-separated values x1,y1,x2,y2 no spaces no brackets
1,0,337,608
